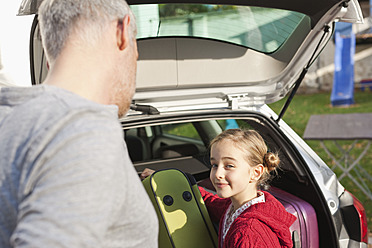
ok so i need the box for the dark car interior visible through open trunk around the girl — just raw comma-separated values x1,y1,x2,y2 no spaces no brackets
124,118,338,247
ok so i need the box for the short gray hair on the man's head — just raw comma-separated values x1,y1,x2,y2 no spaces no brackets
39,0,137,62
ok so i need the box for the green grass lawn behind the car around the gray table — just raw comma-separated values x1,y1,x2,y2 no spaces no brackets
269,90,372,231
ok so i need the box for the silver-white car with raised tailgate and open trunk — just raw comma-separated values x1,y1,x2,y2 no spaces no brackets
20,0,368,248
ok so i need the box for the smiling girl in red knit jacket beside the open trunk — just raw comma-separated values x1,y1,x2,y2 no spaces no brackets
199,129,296,248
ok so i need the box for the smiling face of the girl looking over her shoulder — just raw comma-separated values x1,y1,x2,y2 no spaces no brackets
210,140,263,205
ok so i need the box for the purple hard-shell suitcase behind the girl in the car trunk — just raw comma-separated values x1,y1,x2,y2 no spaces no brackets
269,187,319,248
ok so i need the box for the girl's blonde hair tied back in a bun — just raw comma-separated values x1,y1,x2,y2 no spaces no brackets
210,129,280,189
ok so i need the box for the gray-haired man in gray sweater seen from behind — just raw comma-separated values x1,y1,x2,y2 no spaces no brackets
0,0,158,248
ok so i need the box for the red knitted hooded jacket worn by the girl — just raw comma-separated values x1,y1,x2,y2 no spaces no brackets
199,187,296,248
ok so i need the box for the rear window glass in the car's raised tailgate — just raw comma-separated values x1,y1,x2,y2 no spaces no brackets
131,4,310,53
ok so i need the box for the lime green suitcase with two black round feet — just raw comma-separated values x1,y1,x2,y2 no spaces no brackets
142,169,218,248
